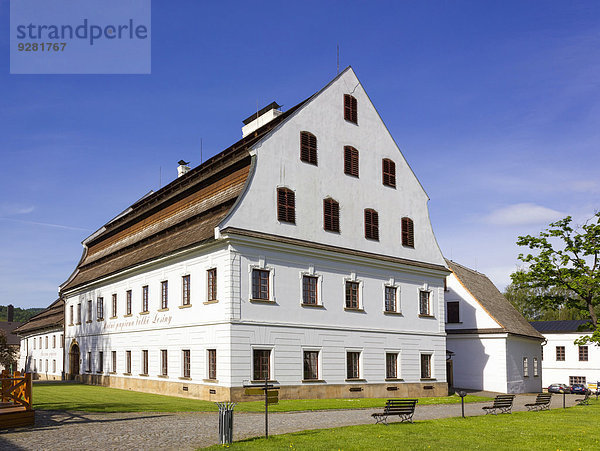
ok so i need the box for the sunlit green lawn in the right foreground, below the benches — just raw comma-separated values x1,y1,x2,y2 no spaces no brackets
208,401,600,451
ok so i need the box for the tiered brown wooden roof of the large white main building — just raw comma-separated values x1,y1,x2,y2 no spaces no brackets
60,99,308,293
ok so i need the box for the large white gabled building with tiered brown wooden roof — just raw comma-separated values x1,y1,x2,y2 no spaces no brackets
60,68,449,400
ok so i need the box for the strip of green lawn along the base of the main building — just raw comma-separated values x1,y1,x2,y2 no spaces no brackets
33,384,490,412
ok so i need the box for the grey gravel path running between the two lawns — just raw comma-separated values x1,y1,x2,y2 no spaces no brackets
0,395,581,451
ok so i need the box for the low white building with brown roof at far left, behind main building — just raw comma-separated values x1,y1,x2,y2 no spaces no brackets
15,299,64,380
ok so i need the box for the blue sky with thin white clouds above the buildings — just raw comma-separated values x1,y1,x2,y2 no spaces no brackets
0,0,600,307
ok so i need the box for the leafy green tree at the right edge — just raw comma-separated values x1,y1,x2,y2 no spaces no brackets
511,212,600,344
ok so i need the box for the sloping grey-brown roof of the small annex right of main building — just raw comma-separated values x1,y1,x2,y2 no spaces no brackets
446,259,544,339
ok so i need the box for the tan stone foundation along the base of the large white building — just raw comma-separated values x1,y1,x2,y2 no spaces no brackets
75,374,448,402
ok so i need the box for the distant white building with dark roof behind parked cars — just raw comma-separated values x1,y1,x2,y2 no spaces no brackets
531,320,600,387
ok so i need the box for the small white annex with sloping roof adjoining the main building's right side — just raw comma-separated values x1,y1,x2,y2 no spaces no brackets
445,260,544,393
